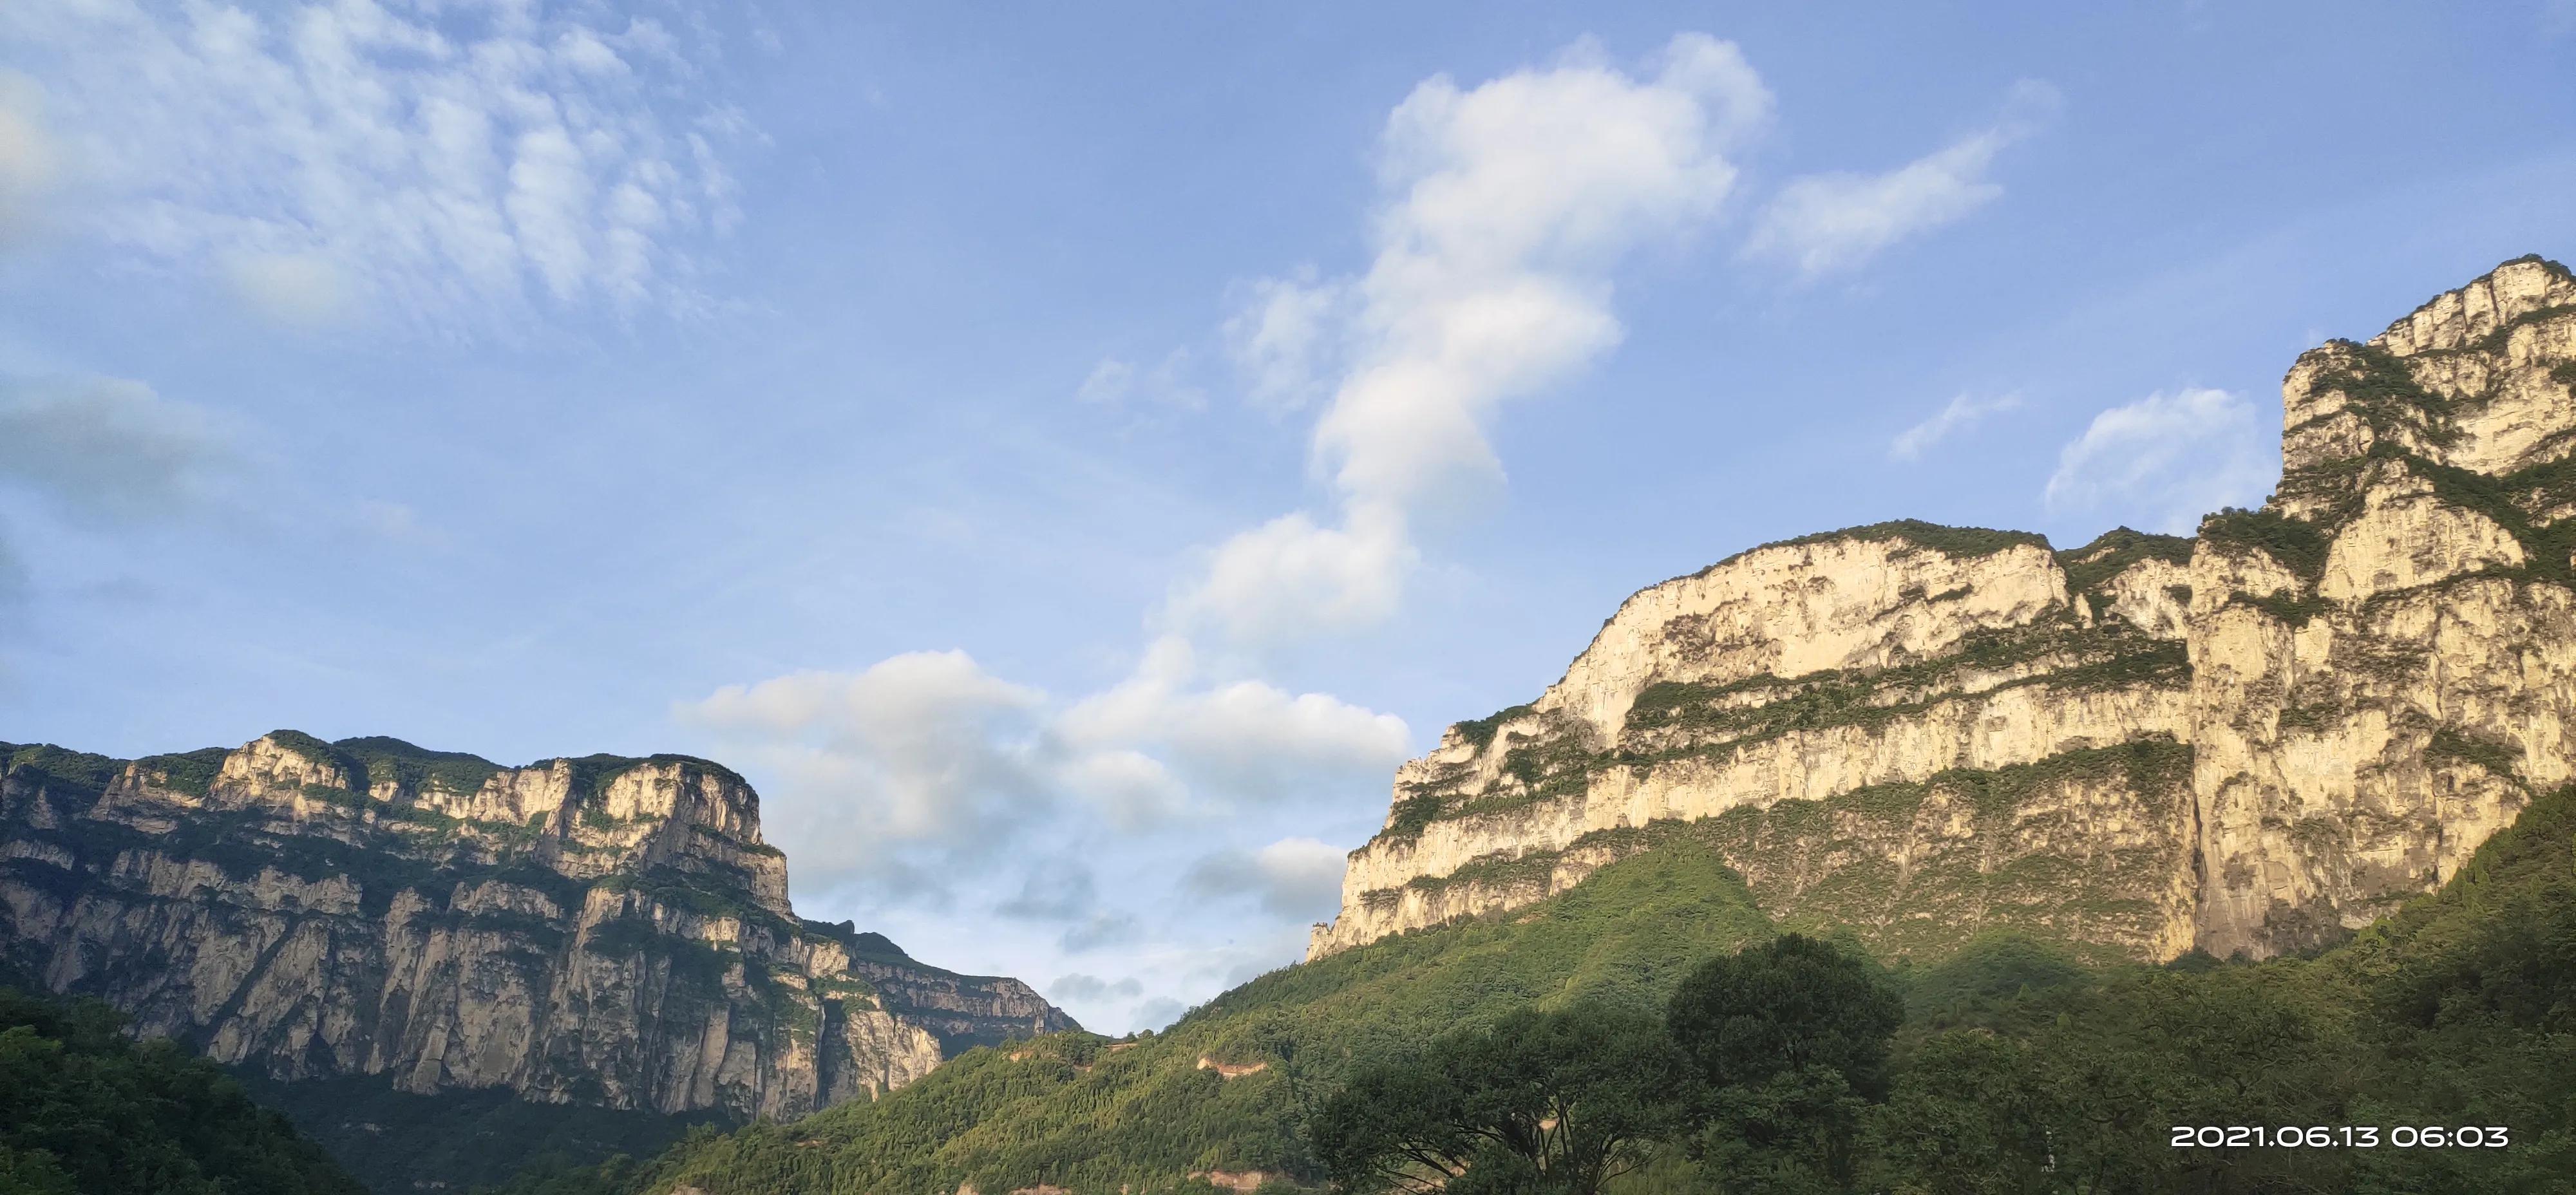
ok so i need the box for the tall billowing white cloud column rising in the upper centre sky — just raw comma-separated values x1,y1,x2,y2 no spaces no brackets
1172,33,1772,644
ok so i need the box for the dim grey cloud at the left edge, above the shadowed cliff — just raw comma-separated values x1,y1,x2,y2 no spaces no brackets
0,379,232,518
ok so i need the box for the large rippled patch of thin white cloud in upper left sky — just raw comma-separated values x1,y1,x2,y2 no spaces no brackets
0,0,739,327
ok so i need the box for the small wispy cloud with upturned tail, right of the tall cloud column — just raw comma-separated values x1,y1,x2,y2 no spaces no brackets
1744,80,2058,278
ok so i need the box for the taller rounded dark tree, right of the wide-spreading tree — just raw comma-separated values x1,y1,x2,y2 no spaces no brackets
1667,935,1904,1192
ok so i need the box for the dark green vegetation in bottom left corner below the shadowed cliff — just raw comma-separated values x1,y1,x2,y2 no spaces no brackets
0,989,363,1195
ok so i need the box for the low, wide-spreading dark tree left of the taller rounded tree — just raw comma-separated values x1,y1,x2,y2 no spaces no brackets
1309,1007,1687,1195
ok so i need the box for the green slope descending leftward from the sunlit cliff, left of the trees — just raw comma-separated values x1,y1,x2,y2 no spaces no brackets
479,852,1770,1195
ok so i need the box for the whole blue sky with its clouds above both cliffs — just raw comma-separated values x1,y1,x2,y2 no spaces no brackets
0,0,2576,1033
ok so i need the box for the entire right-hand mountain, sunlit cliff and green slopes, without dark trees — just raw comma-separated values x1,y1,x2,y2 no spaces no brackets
487,260,2576,1195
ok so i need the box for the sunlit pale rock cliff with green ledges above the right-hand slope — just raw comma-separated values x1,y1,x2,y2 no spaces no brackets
1309,258,2576,958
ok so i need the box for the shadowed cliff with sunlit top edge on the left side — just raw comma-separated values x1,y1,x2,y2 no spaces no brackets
0,731,1072,1118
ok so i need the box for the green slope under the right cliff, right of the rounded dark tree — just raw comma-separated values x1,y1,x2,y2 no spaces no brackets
1870,786,2576,1195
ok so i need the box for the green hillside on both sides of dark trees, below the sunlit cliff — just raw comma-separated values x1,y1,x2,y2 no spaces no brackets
487,788,2576,1195
